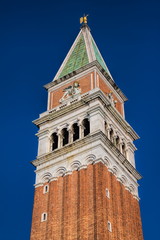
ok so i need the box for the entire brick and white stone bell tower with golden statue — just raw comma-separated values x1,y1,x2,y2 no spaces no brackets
30,16,143,240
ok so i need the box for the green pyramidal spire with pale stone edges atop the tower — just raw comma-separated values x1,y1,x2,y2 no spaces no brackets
54,25,111,80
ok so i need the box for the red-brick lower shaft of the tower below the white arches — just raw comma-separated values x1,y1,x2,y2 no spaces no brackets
31,163,143,240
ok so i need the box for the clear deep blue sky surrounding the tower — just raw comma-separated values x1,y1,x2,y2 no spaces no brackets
0,0,160,240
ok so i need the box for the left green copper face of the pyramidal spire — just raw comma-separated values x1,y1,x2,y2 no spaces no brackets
58,34,89,78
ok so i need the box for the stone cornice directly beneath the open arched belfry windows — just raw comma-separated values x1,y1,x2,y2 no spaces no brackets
31,131,142,180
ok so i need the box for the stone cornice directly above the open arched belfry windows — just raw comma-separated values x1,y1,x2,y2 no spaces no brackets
33,89,139,140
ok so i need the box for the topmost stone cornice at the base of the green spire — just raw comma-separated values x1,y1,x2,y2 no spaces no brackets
44,60,128,101
